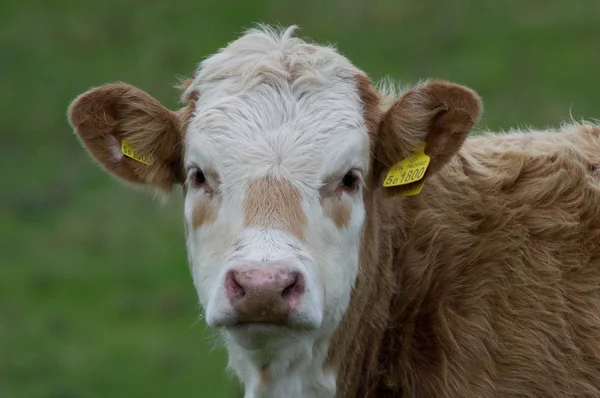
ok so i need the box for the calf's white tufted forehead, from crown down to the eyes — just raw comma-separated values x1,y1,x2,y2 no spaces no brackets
184,25,369,184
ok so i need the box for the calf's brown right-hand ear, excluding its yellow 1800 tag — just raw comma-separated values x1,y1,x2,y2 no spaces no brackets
377,81,482,194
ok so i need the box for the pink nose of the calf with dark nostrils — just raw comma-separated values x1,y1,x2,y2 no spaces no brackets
225,265,305,324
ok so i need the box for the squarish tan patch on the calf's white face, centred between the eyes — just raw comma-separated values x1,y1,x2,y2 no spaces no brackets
244,178,307,239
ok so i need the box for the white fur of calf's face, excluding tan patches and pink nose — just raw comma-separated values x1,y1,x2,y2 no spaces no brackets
185,25,369,396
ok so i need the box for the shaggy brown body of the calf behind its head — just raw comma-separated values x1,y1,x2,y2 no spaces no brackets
329,113,600,398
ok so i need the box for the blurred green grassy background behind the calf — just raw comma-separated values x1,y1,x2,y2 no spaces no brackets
0,0,600,398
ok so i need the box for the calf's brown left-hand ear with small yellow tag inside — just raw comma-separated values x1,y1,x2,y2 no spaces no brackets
68,83,183,192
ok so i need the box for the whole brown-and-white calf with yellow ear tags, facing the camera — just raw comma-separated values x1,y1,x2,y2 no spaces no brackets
68,27,600,397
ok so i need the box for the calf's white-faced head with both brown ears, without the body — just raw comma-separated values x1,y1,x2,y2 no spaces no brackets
69,28,480,393
